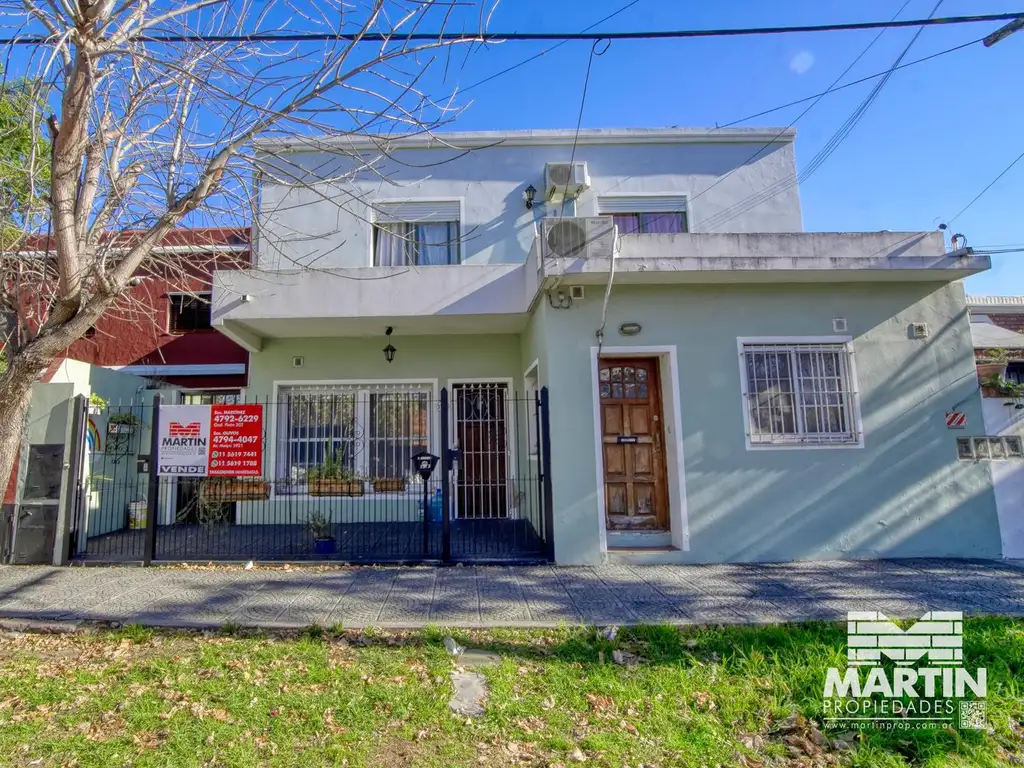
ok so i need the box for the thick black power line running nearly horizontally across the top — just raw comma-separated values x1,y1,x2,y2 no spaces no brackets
0,10,1024,45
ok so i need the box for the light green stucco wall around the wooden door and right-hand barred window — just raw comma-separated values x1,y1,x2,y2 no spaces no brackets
545,283,999,563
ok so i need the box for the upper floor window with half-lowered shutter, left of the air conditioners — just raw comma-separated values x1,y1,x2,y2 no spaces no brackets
374,201,462,266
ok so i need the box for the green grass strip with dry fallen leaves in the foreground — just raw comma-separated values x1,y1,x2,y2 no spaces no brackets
0,620,1024,768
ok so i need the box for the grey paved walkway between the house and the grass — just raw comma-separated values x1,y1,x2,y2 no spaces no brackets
0,560,1024,628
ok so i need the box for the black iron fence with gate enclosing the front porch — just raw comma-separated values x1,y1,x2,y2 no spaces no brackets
72,383,553,562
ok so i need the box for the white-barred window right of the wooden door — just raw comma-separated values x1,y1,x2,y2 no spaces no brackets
742,343,860,446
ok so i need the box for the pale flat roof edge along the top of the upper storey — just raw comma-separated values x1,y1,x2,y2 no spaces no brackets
253,126,797,152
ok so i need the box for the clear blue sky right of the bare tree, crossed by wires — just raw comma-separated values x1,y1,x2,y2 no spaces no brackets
449,0,1024,294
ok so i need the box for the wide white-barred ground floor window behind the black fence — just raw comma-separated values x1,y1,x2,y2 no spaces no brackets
275,383,431,494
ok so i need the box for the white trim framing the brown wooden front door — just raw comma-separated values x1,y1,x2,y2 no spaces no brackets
590,344,690,555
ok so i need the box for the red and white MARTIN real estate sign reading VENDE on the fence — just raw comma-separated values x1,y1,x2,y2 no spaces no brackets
157,406,263,477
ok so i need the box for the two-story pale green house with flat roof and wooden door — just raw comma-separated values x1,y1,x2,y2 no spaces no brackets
213,128,1000,563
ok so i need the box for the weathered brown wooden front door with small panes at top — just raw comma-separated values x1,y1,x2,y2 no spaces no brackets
598,357,669,530
